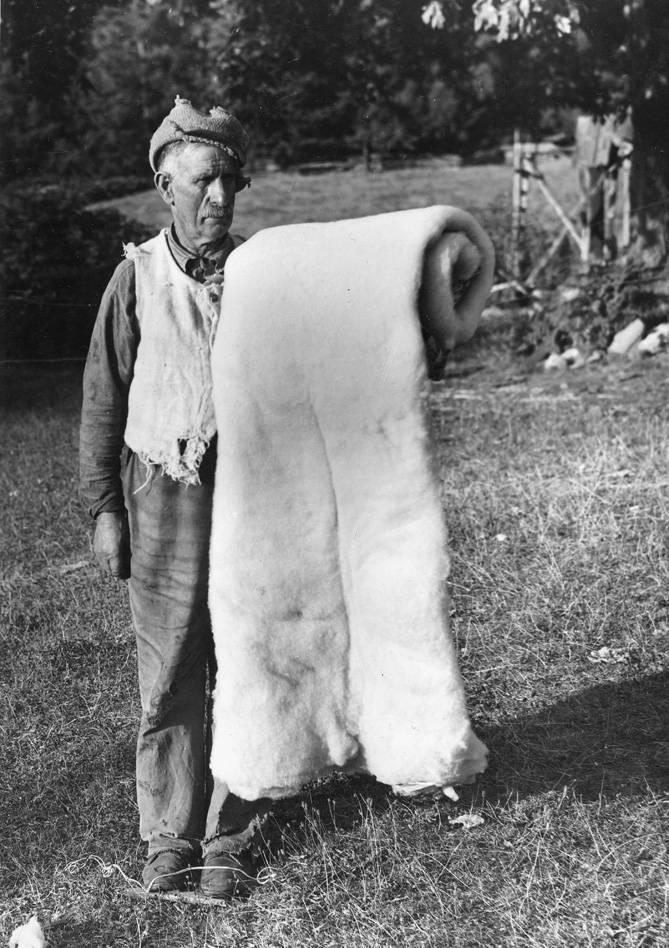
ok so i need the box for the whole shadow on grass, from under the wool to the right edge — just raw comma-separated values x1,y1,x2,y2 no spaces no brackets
272,672,669,848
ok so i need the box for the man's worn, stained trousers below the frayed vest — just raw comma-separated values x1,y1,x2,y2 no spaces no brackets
124,449,269,855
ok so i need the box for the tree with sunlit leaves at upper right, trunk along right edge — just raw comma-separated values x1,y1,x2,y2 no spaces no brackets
423,0,669,256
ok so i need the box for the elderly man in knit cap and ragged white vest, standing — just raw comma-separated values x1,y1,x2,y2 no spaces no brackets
80,98,266,898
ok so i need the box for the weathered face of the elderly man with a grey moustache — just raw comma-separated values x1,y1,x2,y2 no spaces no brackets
156,143,237,254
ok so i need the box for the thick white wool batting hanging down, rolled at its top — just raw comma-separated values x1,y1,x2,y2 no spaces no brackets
210,206,493,799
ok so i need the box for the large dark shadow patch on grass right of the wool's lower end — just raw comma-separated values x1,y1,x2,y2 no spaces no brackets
481,672,669,802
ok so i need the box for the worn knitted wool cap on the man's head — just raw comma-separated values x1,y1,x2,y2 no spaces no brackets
149,96,249,171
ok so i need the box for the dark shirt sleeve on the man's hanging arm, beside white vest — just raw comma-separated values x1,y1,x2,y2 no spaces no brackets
79,260,139,517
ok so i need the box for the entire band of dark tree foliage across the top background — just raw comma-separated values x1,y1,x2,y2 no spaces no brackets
0,0,669,188
